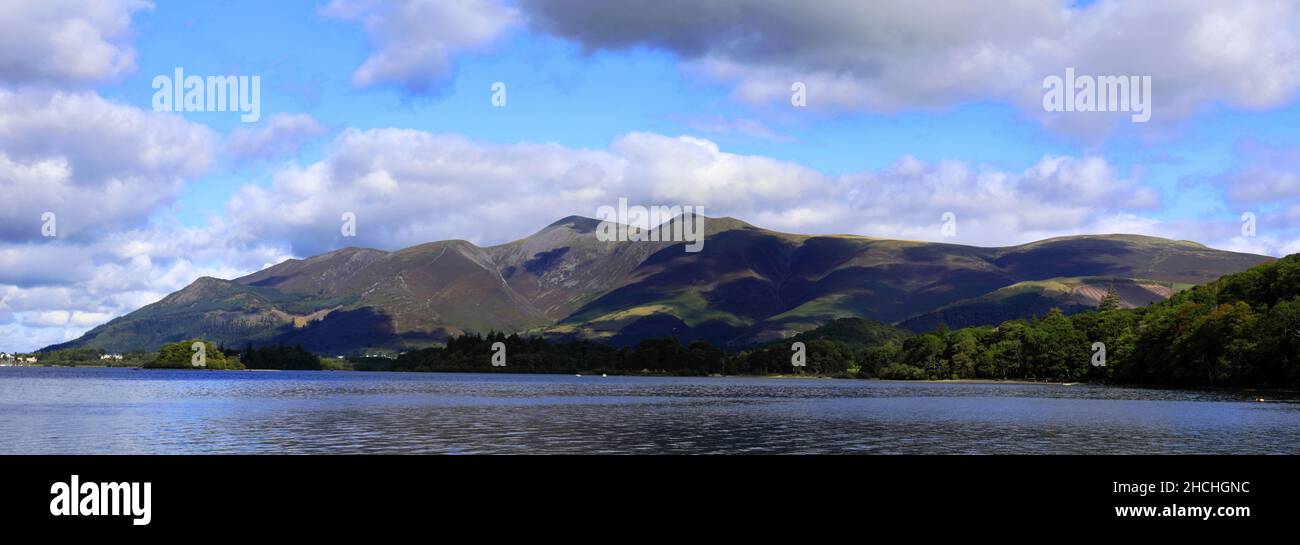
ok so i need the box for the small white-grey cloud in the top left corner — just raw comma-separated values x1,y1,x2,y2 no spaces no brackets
0,0,153,85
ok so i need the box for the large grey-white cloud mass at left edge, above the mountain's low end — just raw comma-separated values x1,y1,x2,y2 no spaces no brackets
0,81,228,350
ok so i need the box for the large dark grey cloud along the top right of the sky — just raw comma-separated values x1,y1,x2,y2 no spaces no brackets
520,0,1300,132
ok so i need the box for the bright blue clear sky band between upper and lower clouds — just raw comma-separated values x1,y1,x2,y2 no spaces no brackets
99,1,1300,226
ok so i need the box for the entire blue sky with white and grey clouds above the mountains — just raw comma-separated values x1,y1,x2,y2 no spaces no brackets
0,0,1300,351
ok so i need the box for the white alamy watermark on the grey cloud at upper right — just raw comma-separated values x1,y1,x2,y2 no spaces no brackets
1043,68,1151,124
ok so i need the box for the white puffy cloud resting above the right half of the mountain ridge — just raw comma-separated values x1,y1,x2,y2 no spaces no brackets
785,156,1158,246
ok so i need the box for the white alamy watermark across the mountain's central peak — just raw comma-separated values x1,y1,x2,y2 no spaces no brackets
595,198,705,254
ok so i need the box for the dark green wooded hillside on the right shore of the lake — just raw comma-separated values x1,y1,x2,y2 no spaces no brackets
871,255,1300,389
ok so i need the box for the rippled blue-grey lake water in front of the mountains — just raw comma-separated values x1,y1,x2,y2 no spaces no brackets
0,367,1300,454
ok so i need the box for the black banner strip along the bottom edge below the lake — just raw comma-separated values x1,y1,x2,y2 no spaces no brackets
0,457,1284,537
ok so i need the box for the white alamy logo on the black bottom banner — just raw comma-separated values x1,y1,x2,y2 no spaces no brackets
49,475,153,525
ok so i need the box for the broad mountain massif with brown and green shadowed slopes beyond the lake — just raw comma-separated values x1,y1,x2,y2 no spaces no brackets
44,216,1270,354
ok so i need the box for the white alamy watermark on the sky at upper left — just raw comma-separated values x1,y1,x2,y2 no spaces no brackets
153,68,261,124
